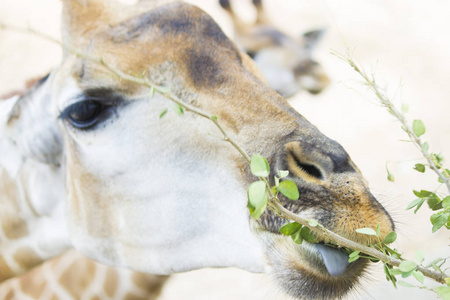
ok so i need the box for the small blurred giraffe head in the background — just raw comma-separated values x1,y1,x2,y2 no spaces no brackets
219,0,330,98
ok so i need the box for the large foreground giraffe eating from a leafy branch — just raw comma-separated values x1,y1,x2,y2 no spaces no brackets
0,0,394,299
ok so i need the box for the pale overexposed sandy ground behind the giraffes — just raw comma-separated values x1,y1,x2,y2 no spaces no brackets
0,0,450,300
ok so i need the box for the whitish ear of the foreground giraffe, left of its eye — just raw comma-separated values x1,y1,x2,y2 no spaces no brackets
0,76,62,165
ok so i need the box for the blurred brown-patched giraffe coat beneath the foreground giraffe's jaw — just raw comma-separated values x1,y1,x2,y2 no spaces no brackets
0,250,169,300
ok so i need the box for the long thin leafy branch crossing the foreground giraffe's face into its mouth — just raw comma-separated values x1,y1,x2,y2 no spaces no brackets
0,23,448,283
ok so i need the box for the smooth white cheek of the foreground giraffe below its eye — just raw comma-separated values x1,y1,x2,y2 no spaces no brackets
54,79,264,274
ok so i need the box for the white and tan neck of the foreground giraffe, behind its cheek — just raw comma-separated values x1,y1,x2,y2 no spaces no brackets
0,98,70,282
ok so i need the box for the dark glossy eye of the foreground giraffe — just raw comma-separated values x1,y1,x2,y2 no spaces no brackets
61,100,107,129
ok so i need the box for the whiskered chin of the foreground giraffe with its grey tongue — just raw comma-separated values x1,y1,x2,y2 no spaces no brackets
264,233,368,299
